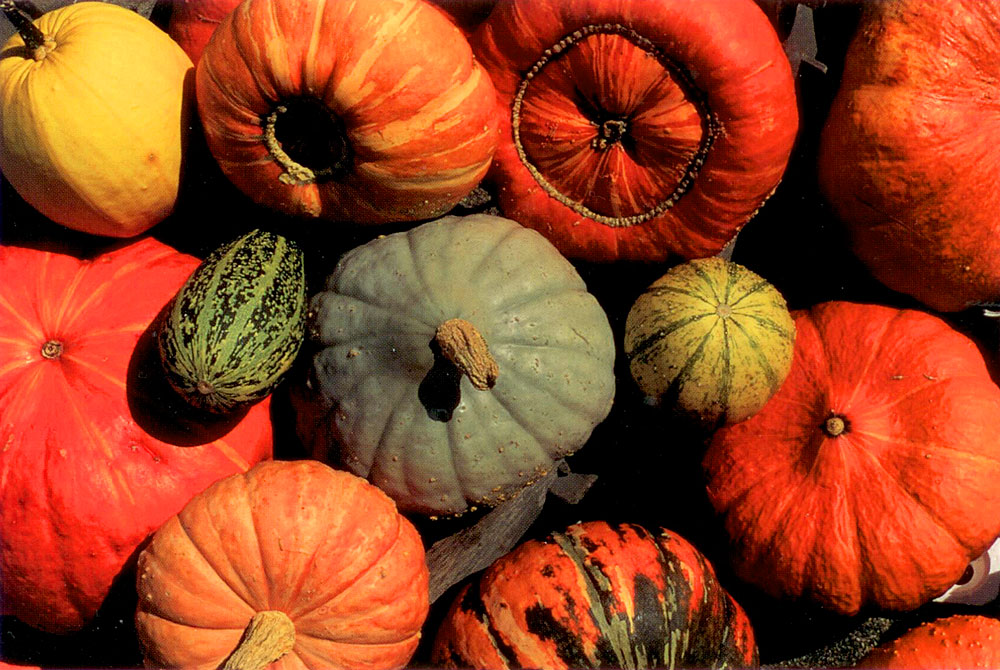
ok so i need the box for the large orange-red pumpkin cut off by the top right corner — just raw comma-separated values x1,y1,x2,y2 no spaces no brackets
818,0,1000,312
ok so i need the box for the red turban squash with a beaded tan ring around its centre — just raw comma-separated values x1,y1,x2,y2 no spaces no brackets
471,0,798,261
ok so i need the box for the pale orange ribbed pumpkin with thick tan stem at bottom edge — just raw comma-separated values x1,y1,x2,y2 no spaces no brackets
136,460,428,670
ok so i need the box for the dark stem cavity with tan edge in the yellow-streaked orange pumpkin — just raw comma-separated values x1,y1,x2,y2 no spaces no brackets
262,97,351,186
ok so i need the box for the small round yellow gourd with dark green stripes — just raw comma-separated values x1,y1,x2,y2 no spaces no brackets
624,257,795,426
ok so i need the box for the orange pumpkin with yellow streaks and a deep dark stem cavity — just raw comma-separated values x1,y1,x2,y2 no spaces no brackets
196,0,498,223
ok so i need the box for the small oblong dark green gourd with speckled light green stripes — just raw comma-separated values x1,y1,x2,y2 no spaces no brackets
158,230,306,414
